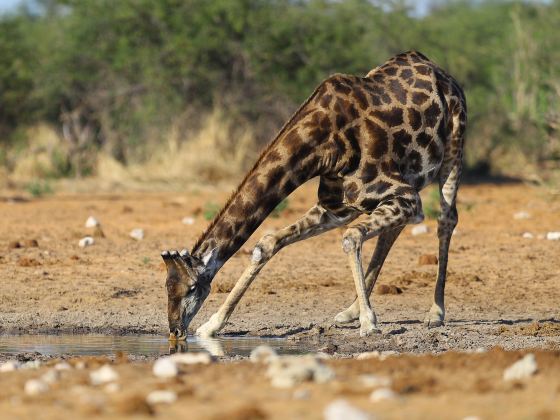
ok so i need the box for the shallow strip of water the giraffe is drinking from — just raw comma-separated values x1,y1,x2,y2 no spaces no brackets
0,334,305,356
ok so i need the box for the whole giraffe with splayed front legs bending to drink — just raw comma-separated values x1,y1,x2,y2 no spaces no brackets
162,51,467,341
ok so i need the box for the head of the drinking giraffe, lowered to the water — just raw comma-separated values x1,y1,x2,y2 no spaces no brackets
161,250,215,341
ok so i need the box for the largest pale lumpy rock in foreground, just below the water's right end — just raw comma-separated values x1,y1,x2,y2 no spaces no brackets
266,355,334,388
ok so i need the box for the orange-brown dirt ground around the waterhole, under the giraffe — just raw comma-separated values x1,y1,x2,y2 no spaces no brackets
0,183,560,418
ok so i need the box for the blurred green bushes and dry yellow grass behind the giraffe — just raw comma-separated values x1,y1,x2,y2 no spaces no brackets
0,0,560,185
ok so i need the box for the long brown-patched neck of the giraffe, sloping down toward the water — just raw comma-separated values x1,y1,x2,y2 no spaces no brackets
192,133,318,281
